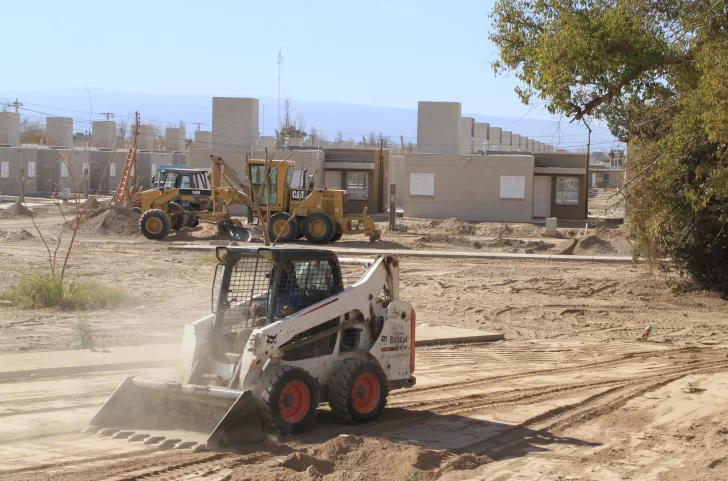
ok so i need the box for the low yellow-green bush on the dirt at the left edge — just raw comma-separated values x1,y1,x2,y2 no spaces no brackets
2,274,124,310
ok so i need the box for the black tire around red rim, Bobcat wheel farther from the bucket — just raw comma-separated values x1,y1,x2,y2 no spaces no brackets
328,359,389,424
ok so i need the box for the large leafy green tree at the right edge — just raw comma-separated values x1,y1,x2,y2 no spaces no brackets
491,0,728,292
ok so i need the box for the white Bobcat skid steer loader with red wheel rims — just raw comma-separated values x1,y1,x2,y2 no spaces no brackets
89,246,415,448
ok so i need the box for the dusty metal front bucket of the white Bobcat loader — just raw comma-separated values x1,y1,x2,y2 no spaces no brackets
89,377,263,449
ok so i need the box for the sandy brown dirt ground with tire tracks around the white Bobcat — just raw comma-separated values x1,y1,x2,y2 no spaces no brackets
0,203,728,481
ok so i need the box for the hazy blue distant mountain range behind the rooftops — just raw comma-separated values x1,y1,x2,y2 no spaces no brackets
0,88,615,151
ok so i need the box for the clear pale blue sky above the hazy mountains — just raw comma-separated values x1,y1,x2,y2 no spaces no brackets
0,0,547,118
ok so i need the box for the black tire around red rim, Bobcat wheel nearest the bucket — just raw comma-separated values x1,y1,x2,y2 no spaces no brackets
258,366,319,435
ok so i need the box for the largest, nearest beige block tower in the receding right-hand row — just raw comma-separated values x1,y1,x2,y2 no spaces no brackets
417,102,462,154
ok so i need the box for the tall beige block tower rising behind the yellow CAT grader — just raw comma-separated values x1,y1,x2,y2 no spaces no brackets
212,97,260,150
